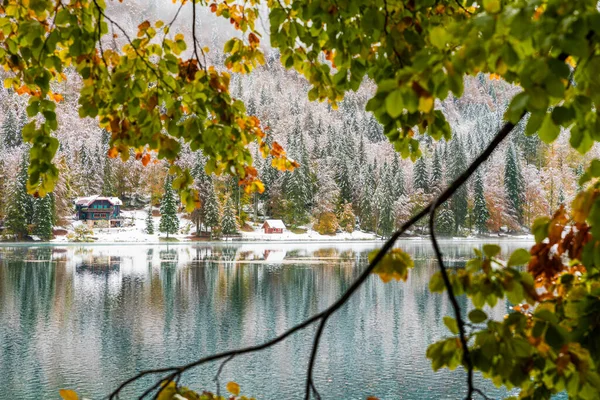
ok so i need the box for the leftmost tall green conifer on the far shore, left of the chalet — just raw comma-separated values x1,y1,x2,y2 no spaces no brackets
4,155,33,239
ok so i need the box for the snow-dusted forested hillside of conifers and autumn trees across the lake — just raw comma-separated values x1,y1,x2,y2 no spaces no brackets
0,2,597,236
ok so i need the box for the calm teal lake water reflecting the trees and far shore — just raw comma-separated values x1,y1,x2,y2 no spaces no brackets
0,240,531,400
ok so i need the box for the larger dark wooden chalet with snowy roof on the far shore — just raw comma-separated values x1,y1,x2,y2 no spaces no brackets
75,196,123,228
